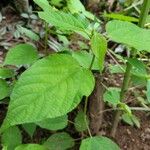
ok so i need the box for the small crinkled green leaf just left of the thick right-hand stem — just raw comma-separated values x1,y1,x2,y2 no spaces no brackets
104,87,120,106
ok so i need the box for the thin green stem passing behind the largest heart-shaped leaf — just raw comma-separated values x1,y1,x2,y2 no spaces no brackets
84,55,95,137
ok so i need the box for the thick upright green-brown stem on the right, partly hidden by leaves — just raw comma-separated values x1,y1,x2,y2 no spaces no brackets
111,0,150,137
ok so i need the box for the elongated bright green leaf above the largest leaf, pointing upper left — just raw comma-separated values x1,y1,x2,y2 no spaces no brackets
38,9,87,32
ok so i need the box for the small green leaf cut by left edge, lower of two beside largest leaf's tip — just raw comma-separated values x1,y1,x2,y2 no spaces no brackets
0,79,9,100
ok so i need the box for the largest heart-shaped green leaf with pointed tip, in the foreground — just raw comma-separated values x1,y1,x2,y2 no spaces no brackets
2,54,95,130
